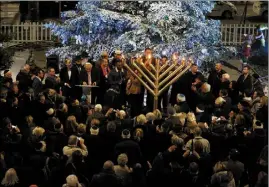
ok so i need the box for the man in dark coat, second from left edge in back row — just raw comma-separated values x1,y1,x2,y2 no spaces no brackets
16,64,32,92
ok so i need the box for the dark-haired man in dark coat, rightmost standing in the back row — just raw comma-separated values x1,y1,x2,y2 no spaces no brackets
237,66,253,95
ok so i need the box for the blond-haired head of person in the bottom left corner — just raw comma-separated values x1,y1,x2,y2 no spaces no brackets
1,168,21,187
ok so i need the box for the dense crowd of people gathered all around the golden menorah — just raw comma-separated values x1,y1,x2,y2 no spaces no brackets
0,48,268,187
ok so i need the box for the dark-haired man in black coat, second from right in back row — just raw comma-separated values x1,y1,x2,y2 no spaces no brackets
208,63,226,97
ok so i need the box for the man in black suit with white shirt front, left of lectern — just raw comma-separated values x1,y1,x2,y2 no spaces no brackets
60,59,75,98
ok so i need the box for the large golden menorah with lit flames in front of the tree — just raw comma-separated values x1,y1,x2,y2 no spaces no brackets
124,55,193,110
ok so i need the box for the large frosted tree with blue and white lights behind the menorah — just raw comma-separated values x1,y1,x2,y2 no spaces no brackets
46,1,231,68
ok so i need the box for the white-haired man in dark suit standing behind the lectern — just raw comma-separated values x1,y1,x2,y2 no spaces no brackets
81,62,100,104
